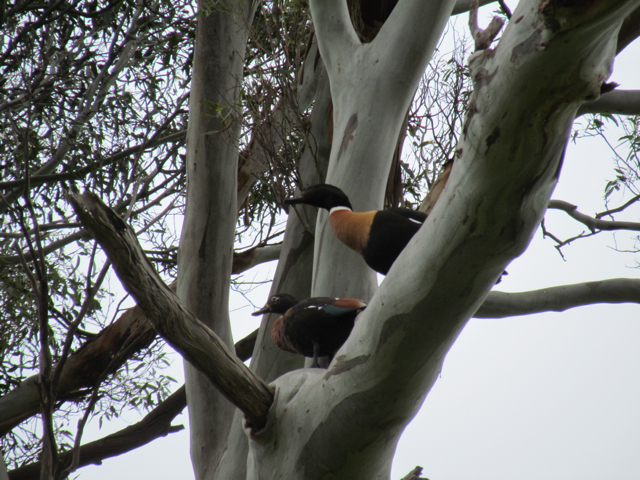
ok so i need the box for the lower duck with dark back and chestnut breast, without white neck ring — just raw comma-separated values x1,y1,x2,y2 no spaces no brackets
252,293,367,367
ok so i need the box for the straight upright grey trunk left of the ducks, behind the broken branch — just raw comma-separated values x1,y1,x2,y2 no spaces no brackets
177,0,254,480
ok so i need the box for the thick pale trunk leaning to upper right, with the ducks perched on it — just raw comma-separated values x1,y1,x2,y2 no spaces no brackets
248,0,640,480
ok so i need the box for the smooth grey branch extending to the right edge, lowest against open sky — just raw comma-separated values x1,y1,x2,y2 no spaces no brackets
473,278,640,318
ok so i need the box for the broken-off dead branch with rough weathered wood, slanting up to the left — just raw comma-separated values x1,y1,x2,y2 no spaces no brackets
68,189,274,428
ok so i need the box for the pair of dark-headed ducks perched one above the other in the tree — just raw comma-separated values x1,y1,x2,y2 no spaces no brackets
253,184,427,367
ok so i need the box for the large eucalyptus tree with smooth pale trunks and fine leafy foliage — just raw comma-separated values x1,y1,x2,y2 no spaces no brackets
0,0,640,479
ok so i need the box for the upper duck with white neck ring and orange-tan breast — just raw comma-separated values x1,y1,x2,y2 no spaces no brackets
284,183,427,275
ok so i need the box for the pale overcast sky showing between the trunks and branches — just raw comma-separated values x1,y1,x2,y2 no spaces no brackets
77,2,640,480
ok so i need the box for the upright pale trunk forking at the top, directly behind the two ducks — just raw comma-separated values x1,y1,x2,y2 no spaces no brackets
311,0,455,300
